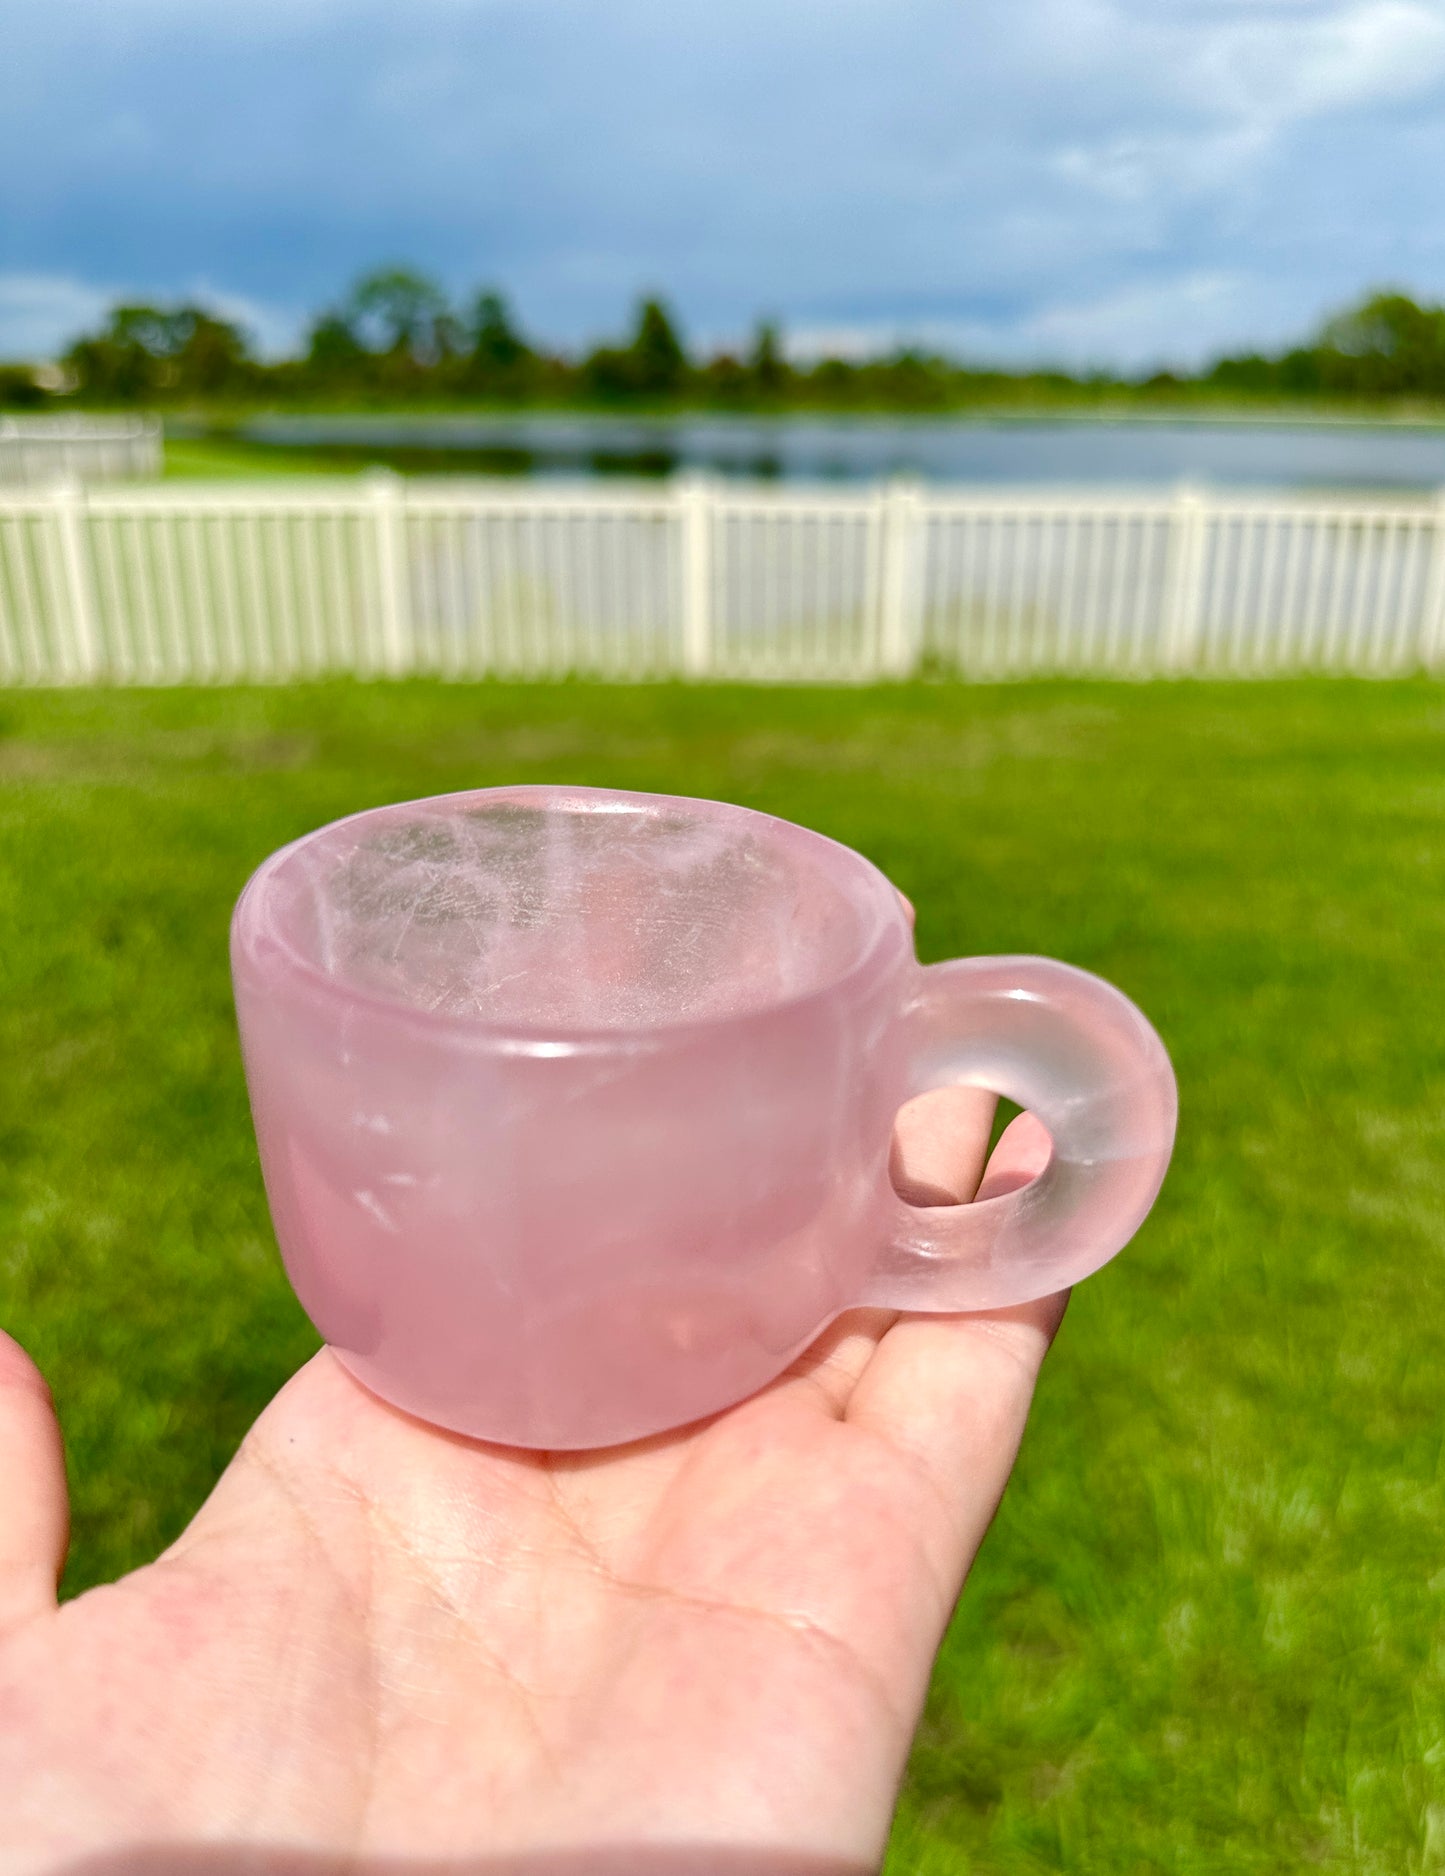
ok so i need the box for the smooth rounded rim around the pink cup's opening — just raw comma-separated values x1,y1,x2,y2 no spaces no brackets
231,782,910,1056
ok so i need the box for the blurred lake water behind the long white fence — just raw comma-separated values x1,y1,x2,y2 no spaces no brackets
238,415,1445,490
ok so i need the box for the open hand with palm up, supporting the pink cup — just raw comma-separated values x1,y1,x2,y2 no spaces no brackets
0,1090,1062,1876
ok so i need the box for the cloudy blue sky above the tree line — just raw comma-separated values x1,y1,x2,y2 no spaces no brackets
0,0,1445,366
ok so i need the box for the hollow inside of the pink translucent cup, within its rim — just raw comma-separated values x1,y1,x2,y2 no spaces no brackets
253,788,897,1030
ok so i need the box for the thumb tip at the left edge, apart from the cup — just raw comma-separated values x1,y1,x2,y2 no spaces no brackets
0,1330,69,1630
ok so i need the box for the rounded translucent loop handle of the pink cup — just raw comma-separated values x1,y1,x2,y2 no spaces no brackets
859,957,1179,1311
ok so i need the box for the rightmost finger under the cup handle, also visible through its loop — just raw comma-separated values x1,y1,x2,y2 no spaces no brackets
846,1114,1068,1583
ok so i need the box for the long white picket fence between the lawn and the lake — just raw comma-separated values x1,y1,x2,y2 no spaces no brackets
0,475,1445,685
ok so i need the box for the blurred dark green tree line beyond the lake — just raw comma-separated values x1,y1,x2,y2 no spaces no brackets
0,266,1445,411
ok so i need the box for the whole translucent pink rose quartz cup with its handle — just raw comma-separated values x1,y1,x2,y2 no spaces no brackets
231,788,1175,1448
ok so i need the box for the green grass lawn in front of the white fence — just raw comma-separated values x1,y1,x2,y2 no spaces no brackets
0,683,1445,1876
